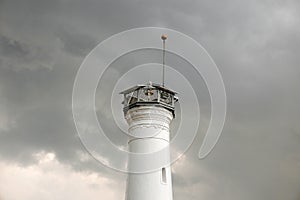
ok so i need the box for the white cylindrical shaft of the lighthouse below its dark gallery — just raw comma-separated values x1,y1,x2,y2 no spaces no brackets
126,106,173,200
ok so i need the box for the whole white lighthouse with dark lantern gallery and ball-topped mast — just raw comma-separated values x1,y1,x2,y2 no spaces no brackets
121,35,177,200
